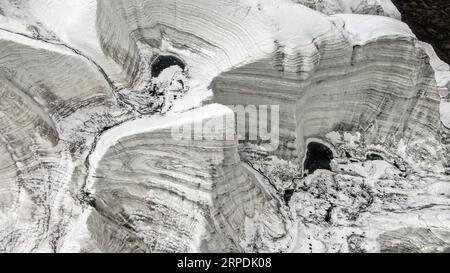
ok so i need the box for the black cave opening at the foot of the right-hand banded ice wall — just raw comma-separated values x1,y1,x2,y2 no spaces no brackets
303,142,333,174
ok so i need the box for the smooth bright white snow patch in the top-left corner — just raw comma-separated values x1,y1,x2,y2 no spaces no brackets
0,0,125,82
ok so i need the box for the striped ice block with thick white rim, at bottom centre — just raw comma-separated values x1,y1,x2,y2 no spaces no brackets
62,105,293,252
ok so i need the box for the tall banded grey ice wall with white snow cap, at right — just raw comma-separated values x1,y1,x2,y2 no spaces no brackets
211,15,441,162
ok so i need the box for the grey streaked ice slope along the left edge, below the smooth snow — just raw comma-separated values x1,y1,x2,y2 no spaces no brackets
0,22,120,251
